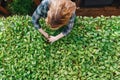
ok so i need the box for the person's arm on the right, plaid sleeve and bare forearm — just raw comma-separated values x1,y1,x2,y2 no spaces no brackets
49,14,76,42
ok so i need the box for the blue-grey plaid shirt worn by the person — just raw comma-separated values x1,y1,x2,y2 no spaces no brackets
32,0,76,35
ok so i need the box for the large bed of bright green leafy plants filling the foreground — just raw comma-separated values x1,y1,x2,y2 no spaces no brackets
0,16,120,80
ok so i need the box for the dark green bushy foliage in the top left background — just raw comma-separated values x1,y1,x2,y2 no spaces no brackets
8,0,35,14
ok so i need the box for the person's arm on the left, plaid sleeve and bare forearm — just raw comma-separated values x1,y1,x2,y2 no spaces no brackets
32,0,48,38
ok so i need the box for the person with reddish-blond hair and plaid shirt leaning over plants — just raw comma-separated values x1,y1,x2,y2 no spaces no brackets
32,0,76,43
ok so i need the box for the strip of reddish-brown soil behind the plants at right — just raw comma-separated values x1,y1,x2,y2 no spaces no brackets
76,6,120,17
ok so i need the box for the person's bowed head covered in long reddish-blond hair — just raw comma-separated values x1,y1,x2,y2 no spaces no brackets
46,0,76,29
